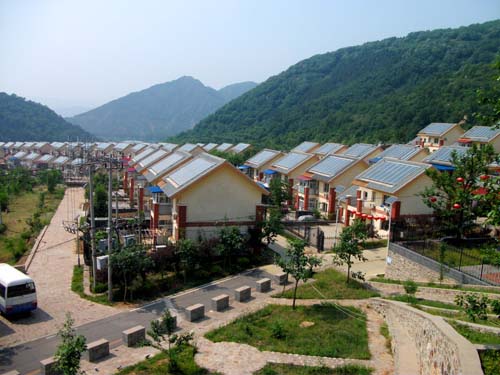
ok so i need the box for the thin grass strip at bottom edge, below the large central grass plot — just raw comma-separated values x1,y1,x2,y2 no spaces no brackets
254,363,372,375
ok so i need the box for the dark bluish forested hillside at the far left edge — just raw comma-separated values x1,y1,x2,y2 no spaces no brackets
0,92,95,142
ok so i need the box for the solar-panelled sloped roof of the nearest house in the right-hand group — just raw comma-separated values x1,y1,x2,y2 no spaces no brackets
354,158,431,194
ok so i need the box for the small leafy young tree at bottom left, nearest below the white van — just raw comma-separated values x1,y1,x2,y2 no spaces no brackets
54,313,87,375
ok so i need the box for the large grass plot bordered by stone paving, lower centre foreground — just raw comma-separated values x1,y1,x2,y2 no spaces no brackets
205,304,370,359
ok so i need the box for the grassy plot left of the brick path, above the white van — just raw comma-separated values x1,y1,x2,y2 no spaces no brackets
0,187,63,264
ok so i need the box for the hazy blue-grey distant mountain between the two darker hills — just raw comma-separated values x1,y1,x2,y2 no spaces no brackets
67,77,256,141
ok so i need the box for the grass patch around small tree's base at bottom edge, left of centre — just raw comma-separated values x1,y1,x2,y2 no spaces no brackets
117,346,211,375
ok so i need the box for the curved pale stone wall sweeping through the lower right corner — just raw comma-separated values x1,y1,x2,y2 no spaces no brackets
371,299,483,375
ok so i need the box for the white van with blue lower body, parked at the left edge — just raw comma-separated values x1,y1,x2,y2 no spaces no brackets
0,263,37,315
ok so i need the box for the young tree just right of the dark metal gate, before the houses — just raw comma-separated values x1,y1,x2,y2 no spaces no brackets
333,219,368,283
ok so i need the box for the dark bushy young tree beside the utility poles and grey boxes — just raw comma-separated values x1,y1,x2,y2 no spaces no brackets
110,244,153,301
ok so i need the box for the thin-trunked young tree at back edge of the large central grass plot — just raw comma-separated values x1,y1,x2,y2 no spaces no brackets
276,239,321,310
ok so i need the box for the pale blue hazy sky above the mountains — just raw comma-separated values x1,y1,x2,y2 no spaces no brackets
0,0,500,115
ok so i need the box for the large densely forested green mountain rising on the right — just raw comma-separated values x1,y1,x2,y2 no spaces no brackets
169,21,500,148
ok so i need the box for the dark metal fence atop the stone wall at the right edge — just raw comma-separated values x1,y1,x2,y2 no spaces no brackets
397,239,500,285
